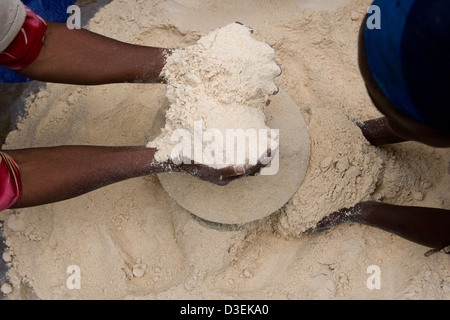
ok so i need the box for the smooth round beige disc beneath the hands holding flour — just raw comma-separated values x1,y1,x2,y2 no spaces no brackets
158,90,310,224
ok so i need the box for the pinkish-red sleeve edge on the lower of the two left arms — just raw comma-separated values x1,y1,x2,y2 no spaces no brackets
0,152,22,211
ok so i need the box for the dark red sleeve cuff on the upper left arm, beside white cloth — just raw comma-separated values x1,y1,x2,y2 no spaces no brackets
0,6,47,70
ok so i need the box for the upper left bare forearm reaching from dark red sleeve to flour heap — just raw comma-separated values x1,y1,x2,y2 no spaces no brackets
17,22,170,85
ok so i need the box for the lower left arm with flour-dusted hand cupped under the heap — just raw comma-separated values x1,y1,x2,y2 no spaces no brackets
4,146,250,208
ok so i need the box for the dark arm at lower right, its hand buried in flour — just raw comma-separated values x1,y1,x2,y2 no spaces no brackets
311,201,450,249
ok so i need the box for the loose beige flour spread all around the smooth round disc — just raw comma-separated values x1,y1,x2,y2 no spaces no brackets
0,0,450,300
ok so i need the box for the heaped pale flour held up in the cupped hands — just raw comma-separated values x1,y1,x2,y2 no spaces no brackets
147,23,281,168
